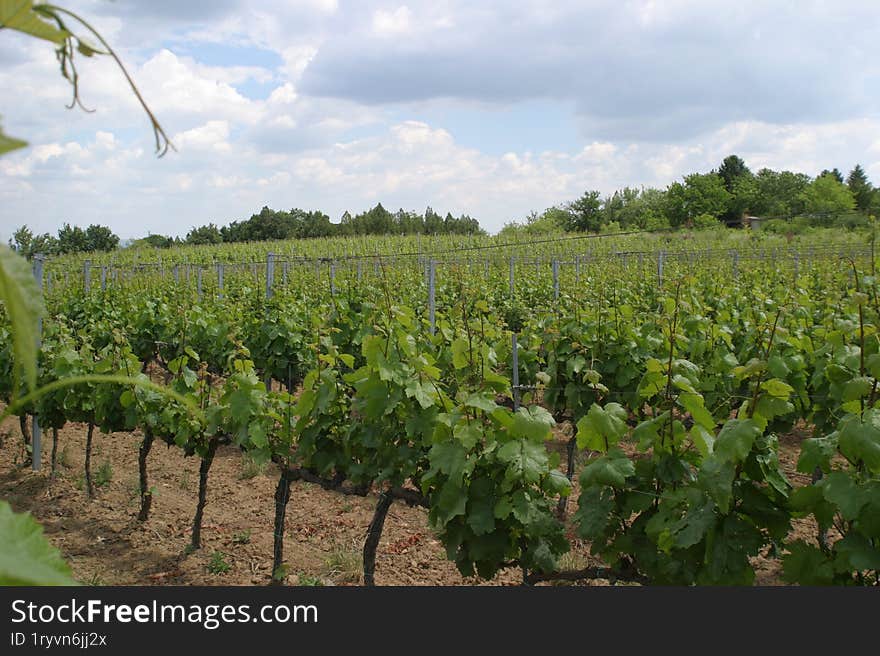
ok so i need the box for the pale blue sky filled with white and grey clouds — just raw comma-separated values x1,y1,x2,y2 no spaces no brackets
0,0,880,241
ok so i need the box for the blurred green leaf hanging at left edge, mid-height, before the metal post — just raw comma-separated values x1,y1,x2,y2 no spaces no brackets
0,244,44,388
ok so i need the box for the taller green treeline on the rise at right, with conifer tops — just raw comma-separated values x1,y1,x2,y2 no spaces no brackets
502,155,880,234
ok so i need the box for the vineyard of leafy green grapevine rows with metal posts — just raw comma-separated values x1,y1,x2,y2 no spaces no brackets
0,231,880,585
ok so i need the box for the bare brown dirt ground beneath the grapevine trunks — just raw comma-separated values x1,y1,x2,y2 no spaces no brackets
0,412,816,585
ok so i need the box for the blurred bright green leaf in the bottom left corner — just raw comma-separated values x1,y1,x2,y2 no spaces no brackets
0,501,78,585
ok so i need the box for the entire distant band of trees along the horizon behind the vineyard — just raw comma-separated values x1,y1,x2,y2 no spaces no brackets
9,155,880,257
